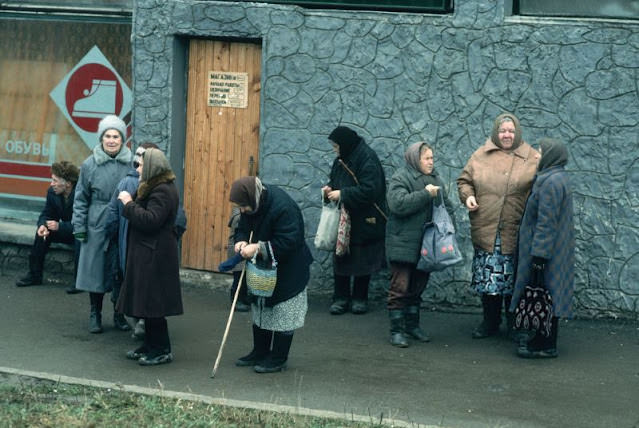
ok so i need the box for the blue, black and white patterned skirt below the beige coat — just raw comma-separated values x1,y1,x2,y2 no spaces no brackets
471,231,515,295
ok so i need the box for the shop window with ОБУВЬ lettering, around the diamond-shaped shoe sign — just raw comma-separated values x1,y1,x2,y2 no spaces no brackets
0,16,132,200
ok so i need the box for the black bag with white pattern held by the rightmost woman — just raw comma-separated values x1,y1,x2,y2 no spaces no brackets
515,285,553,337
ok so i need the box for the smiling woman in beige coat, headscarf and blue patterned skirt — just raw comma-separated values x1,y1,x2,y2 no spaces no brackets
457,113,539,339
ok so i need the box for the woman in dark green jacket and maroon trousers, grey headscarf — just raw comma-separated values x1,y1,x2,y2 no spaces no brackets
386,142,453,348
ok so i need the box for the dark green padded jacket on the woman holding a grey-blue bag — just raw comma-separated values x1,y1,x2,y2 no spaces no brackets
386,167,453,264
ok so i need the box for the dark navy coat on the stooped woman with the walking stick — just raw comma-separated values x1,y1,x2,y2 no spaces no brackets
235,184,313,306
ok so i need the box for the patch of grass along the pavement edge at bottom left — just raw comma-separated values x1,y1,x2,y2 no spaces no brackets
0,377,380,428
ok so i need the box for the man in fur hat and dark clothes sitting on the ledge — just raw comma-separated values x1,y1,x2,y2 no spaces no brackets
16,161,81,294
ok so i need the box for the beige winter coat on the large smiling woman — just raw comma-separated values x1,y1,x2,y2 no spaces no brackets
457,138,539,254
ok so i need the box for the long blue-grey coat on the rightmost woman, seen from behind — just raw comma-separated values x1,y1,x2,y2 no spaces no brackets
510,166,575,318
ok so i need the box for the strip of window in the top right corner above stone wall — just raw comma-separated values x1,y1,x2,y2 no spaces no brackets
513,0,639,19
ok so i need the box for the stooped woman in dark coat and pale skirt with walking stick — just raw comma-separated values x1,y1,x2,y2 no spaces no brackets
229,177,313,373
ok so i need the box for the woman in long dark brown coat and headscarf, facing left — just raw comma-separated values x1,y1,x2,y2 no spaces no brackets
117,148,183,366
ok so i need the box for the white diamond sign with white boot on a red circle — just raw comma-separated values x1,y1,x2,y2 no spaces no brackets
49,46,132,149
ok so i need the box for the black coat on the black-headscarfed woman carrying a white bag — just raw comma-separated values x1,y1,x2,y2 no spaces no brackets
328,139,388,245
